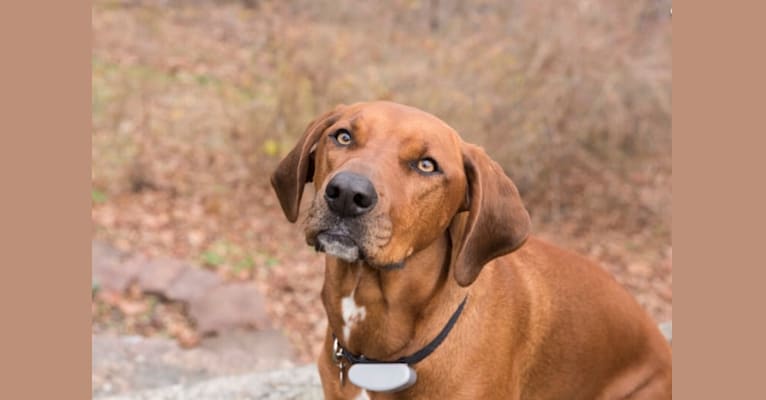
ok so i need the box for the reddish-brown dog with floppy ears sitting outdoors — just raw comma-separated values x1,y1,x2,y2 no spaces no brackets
272,102,671,400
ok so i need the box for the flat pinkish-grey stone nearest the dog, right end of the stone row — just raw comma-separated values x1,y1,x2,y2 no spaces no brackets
189,283,271,334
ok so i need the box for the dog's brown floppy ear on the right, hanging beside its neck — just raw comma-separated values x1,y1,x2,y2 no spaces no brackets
450,143,531,286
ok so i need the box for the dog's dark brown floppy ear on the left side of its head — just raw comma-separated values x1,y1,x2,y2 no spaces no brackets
271,105,344,222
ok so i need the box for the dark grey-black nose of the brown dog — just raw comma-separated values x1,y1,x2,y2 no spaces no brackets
324,172,378,217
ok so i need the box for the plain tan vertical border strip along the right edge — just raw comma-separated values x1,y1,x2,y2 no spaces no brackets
673,0,766,399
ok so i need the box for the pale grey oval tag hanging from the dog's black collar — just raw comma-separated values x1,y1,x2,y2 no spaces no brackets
348,363,418,392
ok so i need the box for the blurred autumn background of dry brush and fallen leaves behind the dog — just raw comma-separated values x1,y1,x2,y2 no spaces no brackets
91,0,672,395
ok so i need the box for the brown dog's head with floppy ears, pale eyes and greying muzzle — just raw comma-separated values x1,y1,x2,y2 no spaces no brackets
271,102,530,286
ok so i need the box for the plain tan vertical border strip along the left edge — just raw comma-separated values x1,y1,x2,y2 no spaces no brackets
0,1,91,399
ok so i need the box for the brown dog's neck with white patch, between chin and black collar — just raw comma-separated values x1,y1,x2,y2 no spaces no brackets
322,234,465,360
